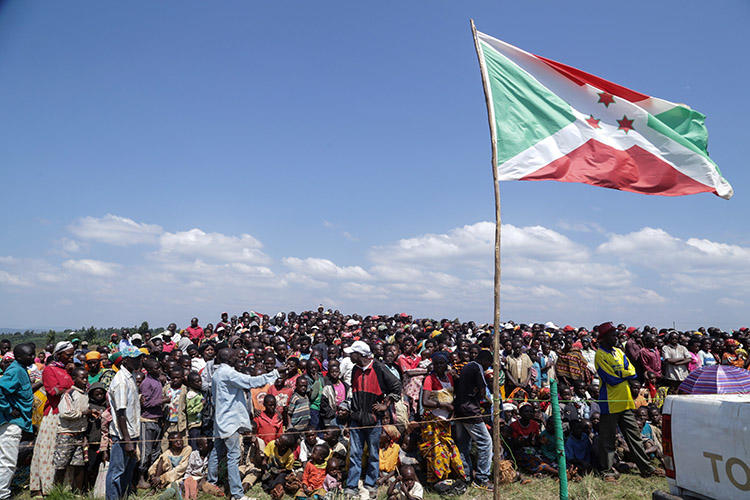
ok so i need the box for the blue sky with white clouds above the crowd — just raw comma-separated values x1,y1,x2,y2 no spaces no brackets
0,0,750,328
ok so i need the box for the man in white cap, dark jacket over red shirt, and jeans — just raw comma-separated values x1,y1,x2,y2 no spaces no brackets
344,340,401,498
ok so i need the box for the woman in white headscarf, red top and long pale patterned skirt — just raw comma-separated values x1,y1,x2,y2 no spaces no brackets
29,341,74,497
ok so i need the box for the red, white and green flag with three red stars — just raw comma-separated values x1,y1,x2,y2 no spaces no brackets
477,32,733,199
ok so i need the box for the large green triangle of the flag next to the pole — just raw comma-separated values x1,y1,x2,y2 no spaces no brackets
481,43,576,164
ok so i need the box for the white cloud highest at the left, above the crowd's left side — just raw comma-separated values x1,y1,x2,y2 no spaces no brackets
69,214,163,246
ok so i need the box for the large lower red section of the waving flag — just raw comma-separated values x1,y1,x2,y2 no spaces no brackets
521,139,716,196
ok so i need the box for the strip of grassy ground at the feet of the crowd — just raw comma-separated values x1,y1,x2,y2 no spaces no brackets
15,474,668,500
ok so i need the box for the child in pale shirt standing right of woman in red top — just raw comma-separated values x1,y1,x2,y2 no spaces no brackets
52,367,94,491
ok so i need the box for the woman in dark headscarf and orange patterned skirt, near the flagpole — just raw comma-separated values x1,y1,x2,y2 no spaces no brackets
419,351,466,485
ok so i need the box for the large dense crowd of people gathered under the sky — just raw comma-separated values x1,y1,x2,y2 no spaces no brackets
0,307,750,500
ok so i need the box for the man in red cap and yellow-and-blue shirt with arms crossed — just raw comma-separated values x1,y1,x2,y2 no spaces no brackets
594,323,664,480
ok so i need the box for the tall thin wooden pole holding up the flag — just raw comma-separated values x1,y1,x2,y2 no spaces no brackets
470,19,503,500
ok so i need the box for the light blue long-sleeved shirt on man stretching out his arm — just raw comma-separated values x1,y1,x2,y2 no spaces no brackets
211,363,279,439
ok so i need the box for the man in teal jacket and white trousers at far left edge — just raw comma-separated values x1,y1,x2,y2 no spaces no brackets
0,344,34,500
